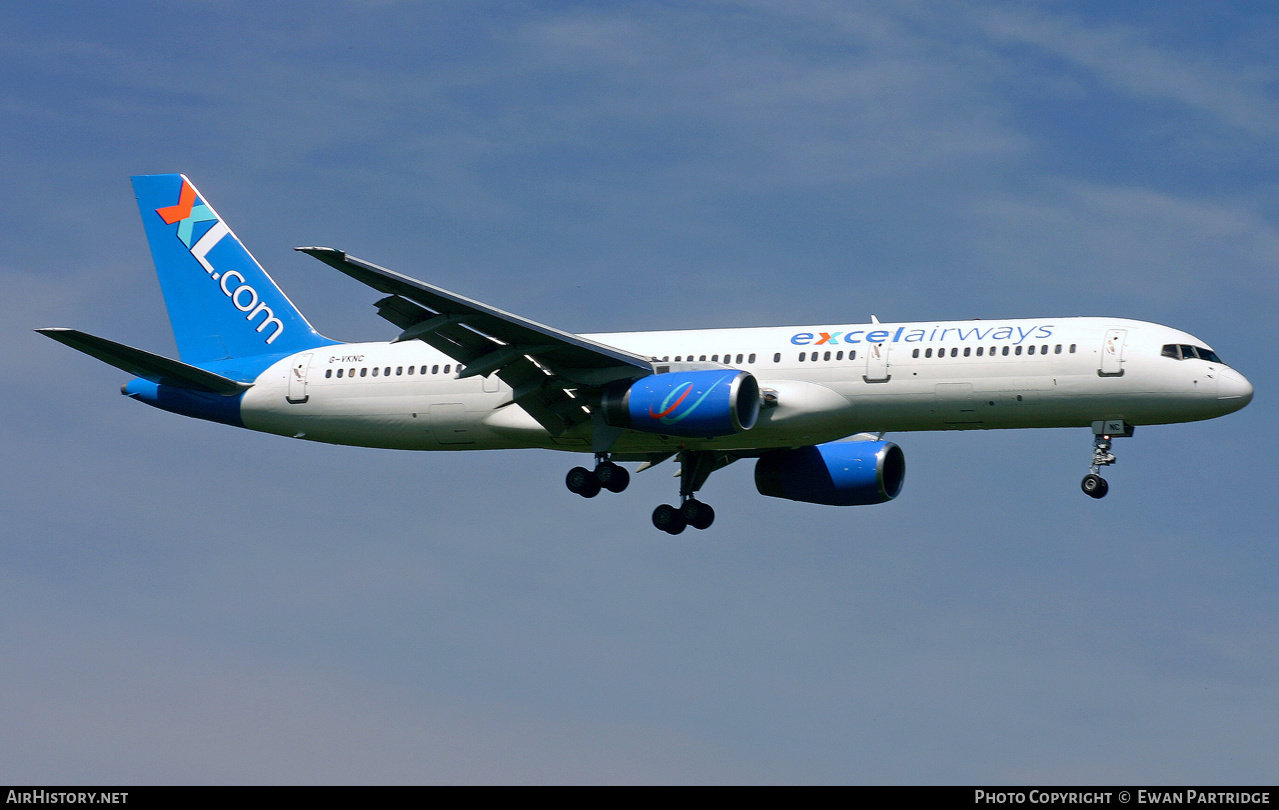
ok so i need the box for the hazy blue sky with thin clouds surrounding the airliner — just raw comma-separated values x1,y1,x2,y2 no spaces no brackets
0,1,1279,783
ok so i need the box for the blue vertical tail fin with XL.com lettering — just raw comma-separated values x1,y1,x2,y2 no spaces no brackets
133,174,335,363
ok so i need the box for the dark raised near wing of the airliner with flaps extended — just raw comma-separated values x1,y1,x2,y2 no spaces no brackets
295,247,654,435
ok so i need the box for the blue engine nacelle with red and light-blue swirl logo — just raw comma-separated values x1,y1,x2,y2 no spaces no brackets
600,369,760,439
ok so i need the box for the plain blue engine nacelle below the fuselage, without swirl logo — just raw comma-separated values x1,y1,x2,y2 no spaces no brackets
755,441,906,507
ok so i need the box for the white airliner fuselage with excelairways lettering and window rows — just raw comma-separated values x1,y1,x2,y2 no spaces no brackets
240,317,1251,453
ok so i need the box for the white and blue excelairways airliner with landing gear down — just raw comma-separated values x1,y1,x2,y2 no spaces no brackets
36,174,1253,535
